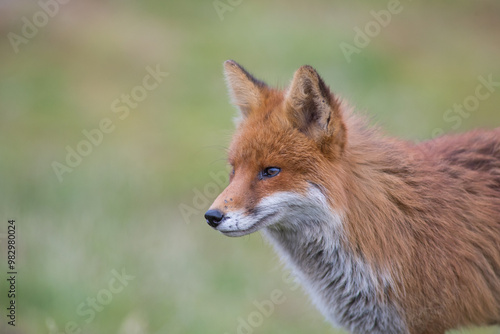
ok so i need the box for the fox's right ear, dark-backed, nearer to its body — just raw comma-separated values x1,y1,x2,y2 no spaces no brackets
285,65,346,157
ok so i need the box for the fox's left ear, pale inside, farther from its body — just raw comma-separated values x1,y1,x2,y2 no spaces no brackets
224,60,267,118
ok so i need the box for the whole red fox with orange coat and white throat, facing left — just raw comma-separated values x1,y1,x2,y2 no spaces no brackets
205,60,500,334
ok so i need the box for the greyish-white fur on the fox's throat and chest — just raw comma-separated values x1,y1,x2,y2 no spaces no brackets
263,215,408,334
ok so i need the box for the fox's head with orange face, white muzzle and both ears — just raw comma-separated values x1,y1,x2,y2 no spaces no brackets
205,60,346,236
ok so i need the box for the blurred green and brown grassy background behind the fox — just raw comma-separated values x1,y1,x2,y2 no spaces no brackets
0,0,500,334
